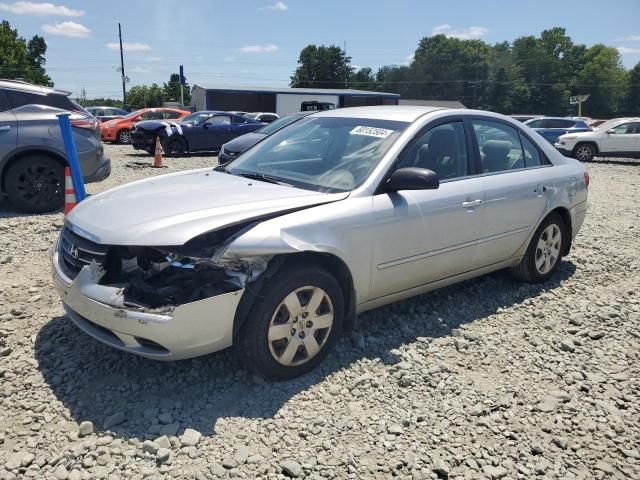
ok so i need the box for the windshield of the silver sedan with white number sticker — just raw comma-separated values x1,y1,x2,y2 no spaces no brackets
226,117,408,193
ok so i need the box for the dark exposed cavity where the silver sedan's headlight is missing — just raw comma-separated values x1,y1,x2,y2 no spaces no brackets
99,246,252,311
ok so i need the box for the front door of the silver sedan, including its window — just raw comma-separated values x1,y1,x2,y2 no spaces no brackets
371,118,484,298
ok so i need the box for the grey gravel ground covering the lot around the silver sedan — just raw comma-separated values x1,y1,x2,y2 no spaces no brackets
0,146,640,479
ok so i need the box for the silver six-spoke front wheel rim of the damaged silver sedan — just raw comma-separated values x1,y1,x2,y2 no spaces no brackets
267,286,334,367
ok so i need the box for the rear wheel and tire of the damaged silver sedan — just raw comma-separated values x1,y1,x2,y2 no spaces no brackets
511,213,568,283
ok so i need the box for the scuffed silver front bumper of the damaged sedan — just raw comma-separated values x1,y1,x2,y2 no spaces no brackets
52,248,244,360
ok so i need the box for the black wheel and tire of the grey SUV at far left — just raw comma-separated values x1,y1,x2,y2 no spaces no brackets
5,155,64,213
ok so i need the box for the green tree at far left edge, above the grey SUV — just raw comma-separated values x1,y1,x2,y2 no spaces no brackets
0,20,53,86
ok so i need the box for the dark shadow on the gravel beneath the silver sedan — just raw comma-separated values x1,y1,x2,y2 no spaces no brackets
35,261,576,438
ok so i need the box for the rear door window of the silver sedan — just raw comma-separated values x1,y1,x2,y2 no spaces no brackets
472,120,525,173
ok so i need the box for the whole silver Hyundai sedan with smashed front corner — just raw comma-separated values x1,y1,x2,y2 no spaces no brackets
52,106,589,379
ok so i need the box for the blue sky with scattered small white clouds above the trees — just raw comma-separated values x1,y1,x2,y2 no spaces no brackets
0,0,640,98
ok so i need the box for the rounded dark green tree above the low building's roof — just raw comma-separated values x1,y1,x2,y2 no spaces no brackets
291,45,353,88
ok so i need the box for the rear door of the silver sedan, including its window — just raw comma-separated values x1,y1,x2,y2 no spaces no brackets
470,117,553,265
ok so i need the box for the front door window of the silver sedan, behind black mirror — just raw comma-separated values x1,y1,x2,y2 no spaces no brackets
398,122,468,180
